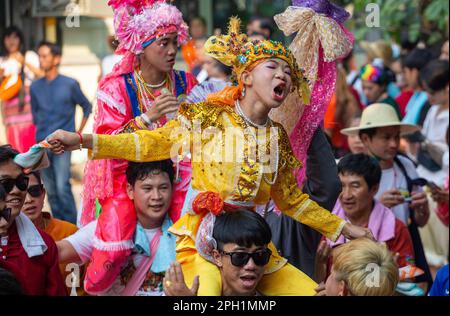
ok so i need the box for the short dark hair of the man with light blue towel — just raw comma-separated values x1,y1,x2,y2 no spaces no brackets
126,159,175,186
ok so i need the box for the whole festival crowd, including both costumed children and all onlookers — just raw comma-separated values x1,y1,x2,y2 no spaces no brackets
0,0,449,296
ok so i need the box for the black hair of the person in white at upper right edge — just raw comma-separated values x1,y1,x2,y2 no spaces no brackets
420,60,449,91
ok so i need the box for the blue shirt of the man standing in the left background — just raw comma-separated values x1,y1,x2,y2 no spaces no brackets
30,75,92,142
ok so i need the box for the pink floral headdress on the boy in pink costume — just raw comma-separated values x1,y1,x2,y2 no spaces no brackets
108,0,189,55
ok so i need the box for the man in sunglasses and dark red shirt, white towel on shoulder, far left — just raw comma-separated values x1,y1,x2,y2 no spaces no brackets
0,145,67,296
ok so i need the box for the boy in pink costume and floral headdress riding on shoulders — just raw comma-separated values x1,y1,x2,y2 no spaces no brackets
81,0,197,294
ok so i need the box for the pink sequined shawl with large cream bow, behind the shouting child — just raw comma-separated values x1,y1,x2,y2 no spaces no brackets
272,7,354,186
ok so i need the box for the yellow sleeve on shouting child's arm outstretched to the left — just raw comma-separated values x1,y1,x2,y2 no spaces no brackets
89,120,190,162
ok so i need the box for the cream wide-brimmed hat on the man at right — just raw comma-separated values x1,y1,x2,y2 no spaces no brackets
341,103,420,136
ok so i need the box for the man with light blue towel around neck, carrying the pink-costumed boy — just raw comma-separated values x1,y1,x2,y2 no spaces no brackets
57,160,175,296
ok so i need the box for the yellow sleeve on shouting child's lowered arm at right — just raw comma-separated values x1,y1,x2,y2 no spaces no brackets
271,122,345,241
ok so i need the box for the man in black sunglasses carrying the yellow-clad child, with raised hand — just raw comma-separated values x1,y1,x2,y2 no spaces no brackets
164,210,272,296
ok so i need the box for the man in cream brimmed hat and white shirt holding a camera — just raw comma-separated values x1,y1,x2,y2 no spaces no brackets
341,103,432,285
